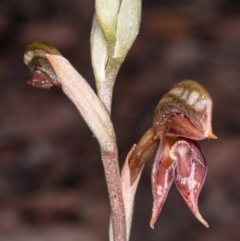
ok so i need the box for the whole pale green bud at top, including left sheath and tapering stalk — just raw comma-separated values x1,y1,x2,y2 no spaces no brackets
91,0,142,113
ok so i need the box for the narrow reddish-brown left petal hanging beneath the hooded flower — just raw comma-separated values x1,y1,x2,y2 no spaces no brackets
150,141,174,228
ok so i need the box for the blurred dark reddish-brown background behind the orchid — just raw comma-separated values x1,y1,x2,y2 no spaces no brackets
0,0,240,241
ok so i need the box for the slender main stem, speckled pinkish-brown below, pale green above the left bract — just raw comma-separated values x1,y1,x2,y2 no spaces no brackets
96,59,128,241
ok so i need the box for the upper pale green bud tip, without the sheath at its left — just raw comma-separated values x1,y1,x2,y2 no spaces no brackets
95,0,141,59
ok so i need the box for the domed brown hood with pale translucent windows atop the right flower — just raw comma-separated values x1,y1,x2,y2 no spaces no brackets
153,80,217,140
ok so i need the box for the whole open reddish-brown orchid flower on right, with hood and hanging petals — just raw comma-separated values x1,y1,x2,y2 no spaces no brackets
128,80,217,228
